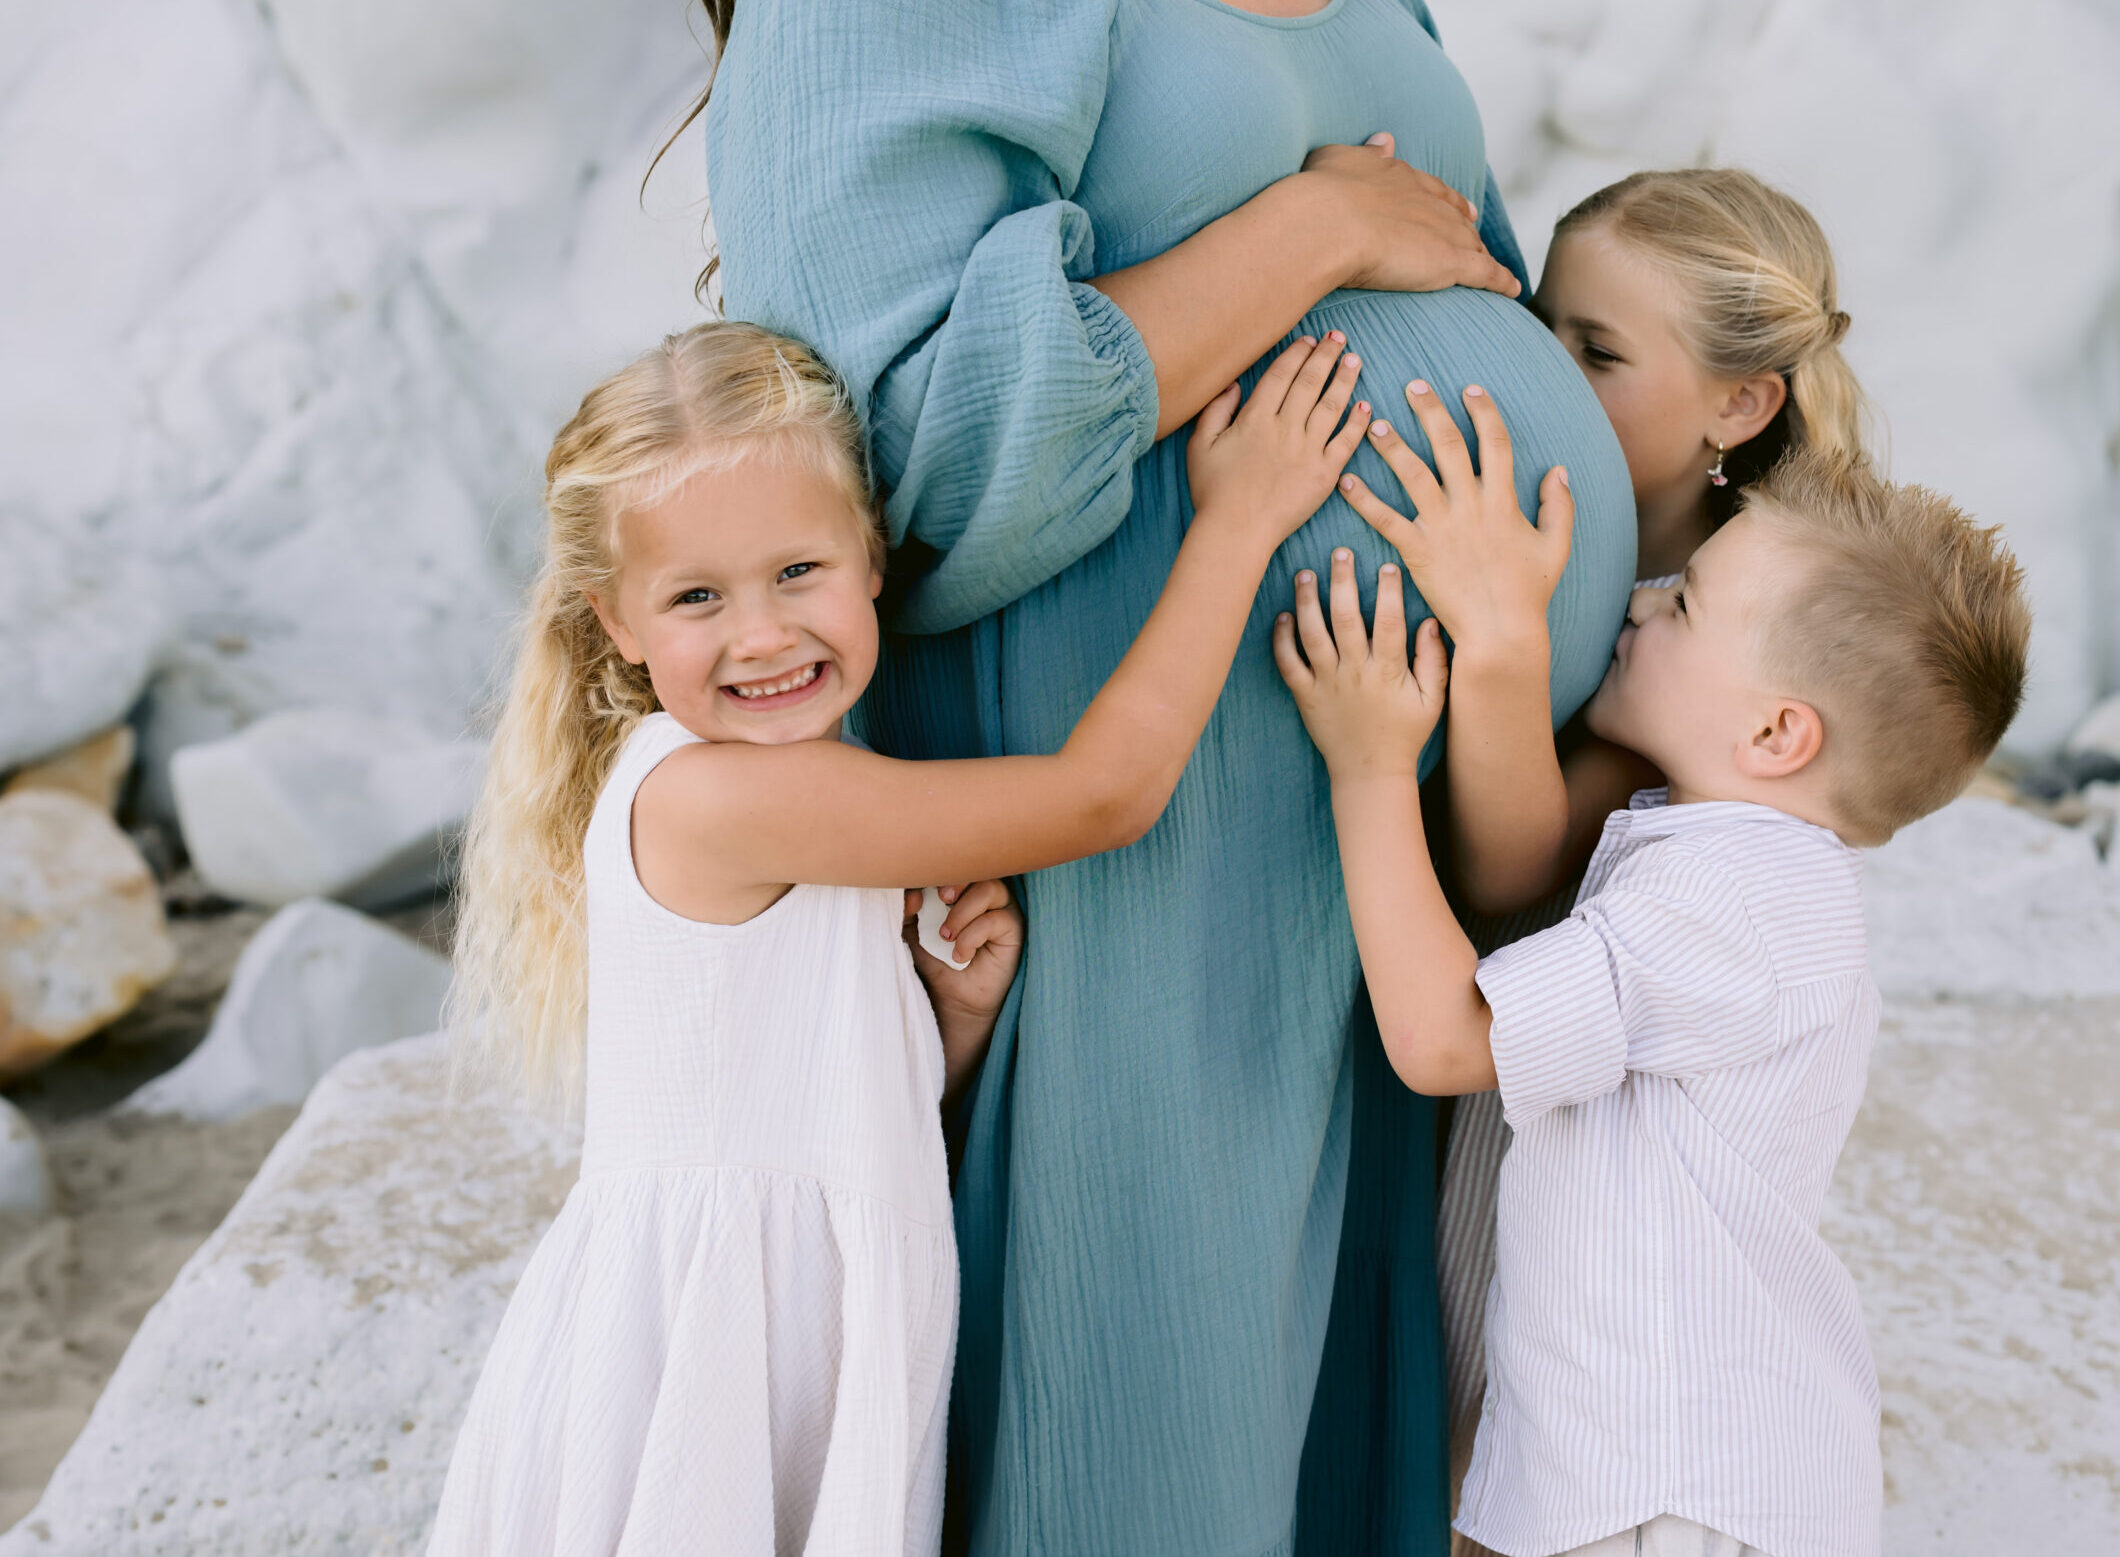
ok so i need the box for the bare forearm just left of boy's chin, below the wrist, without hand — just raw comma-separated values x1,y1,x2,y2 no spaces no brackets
1446,643,1569,914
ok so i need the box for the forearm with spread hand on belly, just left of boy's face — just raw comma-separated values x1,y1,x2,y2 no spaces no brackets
1346,384,1575,914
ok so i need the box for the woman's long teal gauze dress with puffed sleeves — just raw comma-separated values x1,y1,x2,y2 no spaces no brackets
706,0,1635,1557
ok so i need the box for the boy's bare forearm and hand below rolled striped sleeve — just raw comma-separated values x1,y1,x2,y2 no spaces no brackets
1274,552,1495,1097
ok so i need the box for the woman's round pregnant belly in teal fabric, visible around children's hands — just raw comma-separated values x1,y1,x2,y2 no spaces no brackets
1238,286,1635,742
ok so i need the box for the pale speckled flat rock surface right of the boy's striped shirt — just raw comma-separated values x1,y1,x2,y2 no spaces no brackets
1823,999,2120,1557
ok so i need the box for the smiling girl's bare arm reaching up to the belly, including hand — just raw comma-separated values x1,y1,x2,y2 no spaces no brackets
634,339,1370,903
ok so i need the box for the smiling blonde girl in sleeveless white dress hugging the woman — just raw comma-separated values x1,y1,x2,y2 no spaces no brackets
430,322,1370,1557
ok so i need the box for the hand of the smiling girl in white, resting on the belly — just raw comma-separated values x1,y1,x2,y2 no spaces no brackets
1185,331,1370,549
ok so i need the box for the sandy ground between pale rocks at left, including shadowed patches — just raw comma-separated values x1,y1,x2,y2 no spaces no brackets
0,890,452,1529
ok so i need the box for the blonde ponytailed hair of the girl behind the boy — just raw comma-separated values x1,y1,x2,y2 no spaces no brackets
1554,168,1868,522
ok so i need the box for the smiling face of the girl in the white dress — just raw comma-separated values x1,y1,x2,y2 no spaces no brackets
594,452,884,747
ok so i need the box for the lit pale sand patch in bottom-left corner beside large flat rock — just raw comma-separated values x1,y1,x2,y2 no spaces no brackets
0,1107,295,1529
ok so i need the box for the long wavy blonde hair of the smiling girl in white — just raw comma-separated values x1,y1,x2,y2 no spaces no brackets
443,320,882,1103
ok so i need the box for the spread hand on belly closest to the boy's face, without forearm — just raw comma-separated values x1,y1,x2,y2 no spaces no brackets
1340,380,1575,655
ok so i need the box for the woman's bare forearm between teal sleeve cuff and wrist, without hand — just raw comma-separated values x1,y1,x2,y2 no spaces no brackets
1090,174,1357,437
